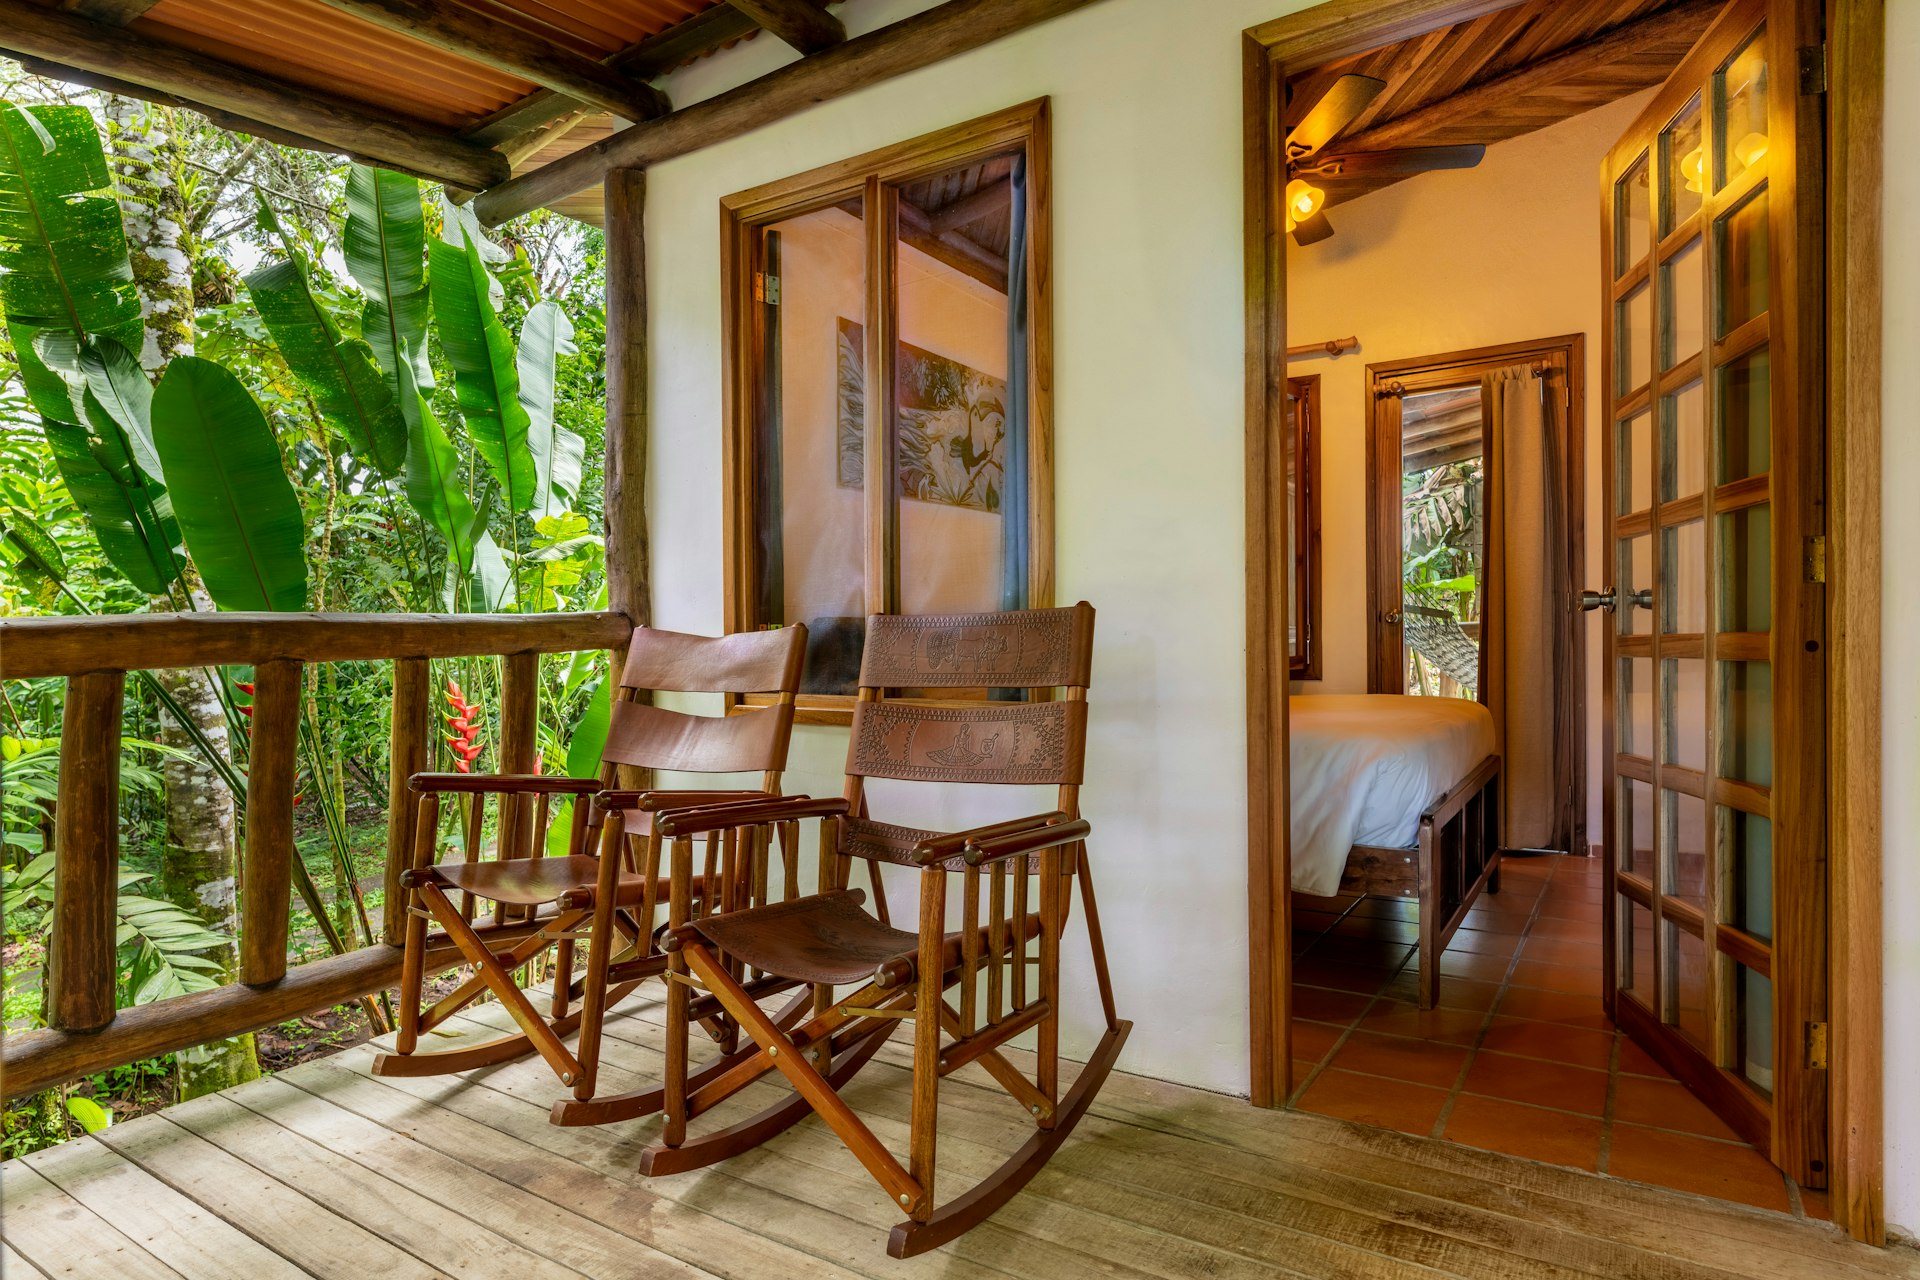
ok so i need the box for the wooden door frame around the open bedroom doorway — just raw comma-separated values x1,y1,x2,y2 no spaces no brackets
1240,0,1885,1244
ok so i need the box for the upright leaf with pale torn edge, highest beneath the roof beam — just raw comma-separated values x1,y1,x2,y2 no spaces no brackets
342,165,434,393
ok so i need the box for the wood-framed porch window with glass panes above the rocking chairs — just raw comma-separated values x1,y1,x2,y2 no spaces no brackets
720,98,1054,723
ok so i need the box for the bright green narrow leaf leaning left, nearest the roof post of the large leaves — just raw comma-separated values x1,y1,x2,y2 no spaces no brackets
430,228,536,510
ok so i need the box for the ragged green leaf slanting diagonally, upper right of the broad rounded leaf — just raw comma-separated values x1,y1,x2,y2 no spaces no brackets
246,248,407,476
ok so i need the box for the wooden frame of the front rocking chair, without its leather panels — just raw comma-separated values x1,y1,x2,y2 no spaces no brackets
641,603,1133,1257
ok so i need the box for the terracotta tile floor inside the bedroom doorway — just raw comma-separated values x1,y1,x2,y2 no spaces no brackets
1292,856,1828,1219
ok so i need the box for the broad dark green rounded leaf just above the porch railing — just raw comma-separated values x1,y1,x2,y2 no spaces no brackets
154,355,307,610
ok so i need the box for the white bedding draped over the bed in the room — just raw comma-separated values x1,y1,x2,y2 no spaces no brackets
1288,693,1494,898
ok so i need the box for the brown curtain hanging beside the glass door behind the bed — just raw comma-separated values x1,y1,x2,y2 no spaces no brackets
1480,363,1580,850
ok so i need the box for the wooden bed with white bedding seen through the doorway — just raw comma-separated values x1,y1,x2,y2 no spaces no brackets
1288,693,1500,1009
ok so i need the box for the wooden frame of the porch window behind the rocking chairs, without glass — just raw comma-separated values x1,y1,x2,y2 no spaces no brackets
720,98,1054,725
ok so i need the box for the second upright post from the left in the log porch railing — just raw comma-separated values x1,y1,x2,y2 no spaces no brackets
240,660,303,986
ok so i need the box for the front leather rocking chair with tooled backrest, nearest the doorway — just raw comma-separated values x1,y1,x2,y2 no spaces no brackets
641,603,1133,1257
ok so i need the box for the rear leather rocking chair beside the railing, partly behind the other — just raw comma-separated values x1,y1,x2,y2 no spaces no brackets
372,626,806,1125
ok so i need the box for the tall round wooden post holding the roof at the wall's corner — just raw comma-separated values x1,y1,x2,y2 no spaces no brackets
603,169,653,787
